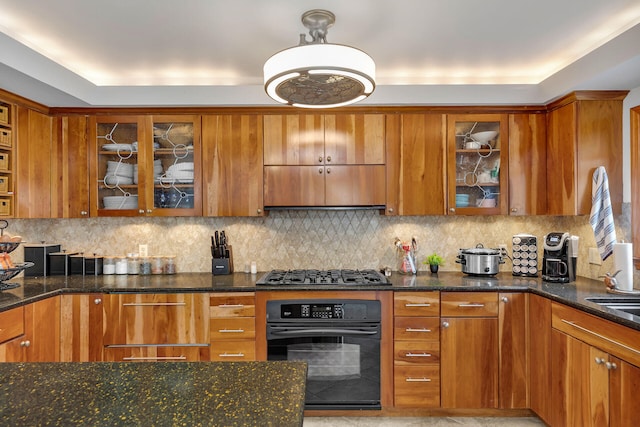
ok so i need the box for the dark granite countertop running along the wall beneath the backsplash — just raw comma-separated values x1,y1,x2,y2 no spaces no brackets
0,272,640,330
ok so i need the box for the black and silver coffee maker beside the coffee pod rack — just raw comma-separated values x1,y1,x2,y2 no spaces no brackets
542,232,579,283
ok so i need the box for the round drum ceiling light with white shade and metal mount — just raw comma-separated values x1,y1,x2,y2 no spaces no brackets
264,9,376,108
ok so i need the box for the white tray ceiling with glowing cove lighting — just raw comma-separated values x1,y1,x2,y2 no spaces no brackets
0,0,640,107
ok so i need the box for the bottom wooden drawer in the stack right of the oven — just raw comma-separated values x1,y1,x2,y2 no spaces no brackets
393,366,440,408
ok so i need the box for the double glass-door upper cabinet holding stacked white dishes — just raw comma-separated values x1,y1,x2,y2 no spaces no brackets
90,116,202,216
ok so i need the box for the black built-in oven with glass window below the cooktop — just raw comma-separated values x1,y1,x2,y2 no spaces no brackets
266,299,381,409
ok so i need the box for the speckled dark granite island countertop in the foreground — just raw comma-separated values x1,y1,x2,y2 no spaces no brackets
0,361,307,427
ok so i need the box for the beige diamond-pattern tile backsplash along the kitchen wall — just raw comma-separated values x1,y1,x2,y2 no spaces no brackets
7,204,631,286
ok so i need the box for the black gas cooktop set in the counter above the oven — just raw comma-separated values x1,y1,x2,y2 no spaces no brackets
256,270,389,285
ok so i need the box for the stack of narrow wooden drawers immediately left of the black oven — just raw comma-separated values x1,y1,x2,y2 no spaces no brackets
209,292,256,361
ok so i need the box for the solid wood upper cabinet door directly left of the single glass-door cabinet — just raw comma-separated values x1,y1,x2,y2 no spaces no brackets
386,113,446,215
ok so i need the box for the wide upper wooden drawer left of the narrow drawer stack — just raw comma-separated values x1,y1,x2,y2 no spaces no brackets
103,293,209,345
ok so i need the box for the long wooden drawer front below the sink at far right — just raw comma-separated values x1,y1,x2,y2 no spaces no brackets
551,303,640,366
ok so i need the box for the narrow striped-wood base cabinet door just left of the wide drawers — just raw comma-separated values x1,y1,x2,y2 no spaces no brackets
60,294,103,362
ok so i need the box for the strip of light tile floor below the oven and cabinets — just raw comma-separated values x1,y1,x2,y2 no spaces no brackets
303,417,545,427
